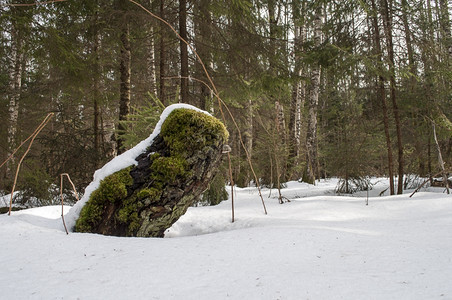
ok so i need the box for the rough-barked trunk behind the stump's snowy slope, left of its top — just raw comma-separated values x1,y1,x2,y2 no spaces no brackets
117,22,130,154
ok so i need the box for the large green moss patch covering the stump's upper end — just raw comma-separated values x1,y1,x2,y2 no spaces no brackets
161,109,229,157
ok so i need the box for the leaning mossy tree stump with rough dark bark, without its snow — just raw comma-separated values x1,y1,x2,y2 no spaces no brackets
75,108,228,237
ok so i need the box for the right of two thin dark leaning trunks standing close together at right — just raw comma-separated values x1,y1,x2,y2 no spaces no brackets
381,0,404,194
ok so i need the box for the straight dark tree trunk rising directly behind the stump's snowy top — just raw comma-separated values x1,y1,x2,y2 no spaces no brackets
179,0,189,103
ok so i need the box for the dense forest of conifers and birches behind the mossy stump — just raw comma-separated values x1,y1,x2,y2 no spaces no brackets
0,0,452,205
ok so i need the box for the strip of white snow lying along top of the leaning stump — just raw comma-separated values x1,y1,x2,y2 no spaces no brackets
66,103,210,230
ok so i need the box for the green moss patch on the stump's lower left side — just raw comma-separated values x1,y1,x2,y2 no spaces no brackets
75,166,133,232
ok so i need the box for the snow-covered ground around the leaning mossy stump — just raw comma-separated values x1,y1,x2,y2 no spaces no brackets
0,180,452,300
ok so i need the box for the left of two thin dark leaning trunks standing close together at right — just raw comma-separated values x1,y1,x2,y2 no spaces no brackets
371,0,394,195
